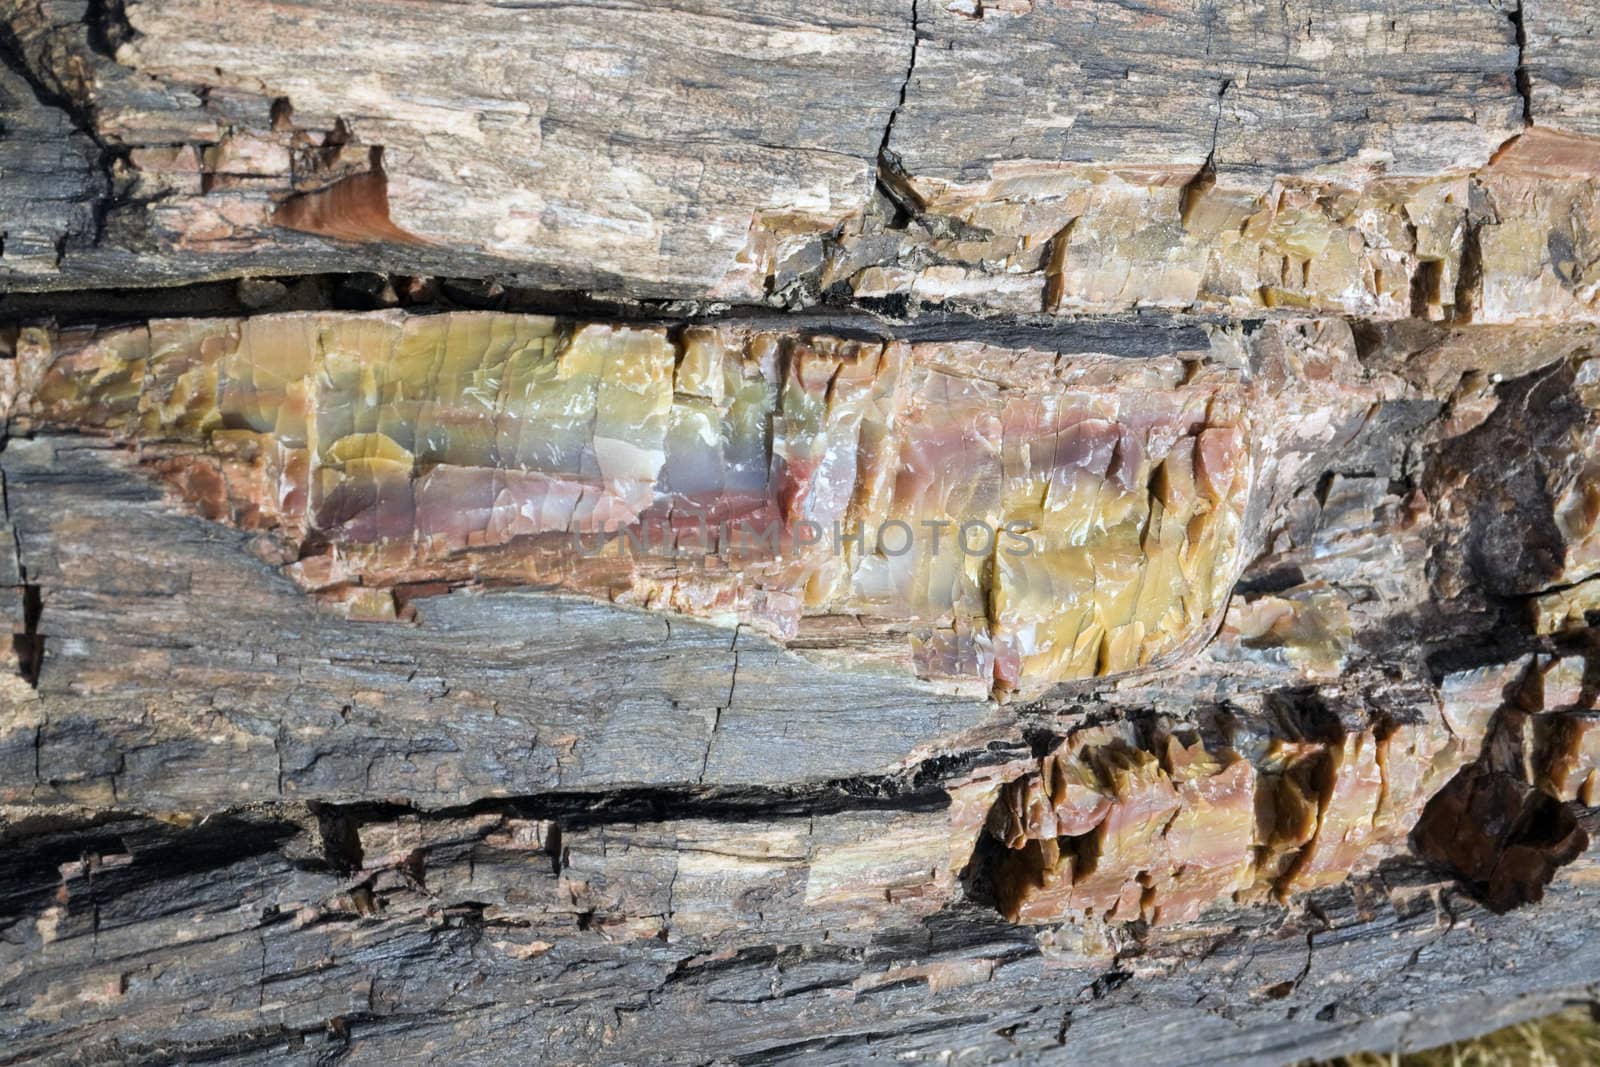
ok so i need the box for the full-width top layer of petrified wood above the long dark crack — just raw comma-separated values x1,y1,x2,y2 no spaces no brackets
0,0,1600,322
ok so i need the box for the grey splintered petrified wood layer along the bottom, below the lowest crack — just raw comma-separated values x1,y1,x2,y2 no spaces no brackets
9,806,1600,1067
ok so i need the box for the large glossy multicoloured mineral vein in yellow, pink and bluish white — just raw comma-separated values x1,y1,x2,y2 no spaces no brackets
19,314,1251,694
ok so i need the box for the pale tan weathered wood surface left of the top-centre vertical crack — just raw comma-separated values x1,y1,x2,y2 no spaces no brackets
0,0,910,296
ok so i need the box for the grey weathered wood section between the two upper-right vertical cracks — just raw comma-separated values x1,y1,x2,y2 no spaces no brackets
888,0,1523,189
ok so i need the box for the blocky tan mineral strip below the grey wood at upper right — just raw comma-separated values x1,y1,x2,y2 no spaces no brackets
821,120,1600,323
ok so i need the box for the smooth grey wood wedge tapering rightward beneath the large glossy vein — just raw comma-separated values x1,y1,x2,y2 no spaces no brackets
0,438,994,811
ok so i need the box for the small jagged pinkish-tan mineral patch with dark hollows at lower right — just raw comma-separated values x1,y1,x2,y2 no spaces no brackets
987,703,1427,923
